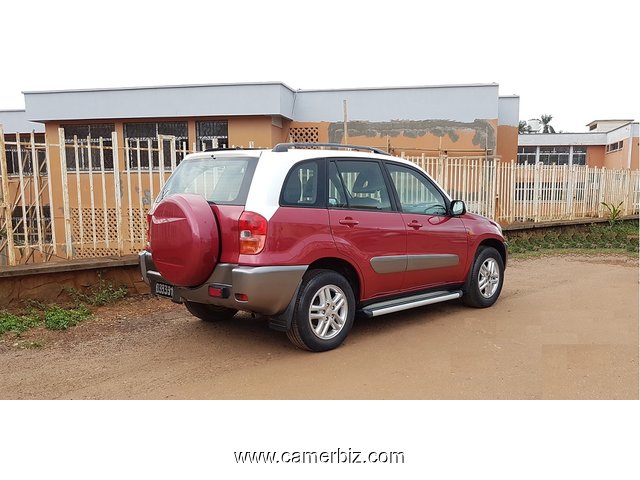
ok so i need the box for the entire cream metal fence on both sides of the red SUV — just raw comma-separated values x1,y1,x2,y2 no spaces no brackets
0,127,640,267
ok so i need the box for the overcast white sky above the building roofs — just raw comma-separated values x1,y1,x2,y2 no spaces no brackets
0,0,640,131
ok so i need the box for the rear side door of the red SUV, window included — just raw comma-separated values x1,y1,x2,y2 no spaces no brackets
328,159,407,300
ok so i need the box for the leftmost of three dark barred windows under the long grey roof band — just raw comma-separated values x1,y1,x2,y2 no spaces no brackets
62,123,115,172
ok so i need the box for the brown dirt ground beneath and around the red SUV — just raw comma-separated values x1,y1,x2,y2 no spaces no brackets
0,256,639,399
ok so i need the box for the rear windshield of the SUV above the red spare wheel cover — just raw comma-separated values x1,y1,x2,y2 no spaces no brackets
158,157,258,205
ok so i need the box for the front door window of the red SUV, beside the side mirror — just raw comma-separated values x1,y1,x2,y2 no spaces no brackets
387,163,447,215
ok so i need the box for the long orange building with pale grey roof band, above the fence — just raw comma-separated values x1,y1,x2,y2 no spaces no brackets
0,82,519,160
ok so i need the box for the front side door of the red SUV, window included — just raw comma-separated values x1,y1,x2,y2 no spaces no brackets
386,162,468,290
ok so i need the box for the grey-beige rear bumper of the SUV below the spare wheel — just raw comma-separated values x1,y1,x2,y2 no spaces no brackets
138,251,308,315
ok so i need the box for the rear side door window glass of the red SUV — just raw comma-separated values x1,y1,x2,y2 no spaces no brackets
329,160,391,211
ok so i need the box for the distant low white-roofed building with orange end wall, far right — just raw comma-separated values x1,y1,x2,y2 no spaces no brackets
518,120,640,170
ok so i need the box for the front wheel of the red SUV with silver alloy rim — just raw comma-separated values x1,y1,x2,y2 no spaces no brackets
462,247,504,308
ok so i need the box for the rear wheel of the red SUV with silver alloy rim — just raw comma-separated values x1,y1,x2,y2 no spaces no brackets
287,270,356,352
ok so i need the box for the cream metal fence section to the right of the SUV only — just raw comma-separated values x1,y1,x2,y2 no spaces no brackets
405,157,640,225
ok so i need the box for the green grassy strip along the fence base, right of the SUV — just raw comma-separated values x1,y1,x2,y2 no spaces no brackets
505,220,639,256
